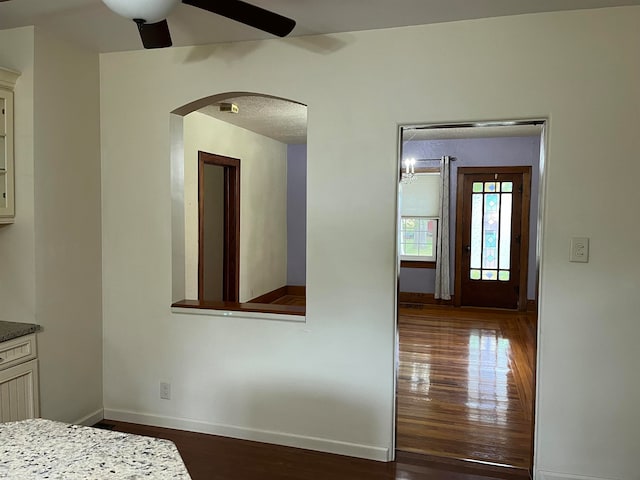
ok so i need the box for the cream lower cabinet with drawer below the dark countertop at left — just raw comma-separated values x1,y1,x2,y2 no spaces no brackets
0,335,40,422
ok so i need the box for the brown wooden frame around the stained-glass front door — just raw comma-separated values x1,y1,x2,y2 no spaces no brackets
453,166,532,312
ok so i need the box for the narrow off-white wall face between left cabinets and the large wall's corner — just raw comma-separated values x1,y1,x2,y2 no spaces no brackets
34,29,102,421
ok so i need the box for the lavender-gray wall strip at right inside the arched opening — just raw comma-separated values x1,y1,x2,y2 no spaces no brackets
287,144,307,285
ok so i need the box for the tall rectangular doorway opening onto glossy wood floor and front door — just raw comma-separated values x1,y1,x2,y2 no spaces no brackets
396,120,545,475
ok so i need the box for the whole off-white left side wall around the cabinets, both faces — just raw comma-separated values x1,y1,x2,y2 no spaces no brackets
0,27,102,421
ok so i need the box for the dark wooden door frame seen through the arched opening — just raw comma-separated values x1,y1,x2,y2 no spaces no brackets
198,151,240,302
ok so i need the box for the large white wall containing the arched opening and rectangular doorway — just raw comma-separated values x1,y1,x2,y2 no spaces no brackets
101,7,640,479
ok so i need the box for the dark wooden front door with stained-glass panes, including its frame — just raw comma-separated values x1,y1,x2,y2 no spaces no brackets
455,167,531,310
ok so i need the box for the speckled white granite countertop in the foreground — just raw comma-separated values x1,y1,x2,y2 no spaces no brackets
0,419,191,480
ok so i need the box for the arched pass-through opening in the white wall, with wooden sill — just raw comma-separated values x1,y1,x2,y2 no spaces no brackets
171,92,307,318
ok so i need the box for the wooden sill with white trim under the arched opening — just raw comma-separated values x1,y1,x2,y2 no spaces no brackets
171,300,307,323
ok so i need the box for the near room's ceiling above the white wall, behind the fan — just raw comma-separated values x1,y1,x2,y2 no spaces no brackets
0,0,640,52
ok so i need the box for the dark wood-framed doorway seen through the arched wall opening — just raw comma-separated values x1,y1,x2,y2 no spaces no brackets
198,151,240,302
